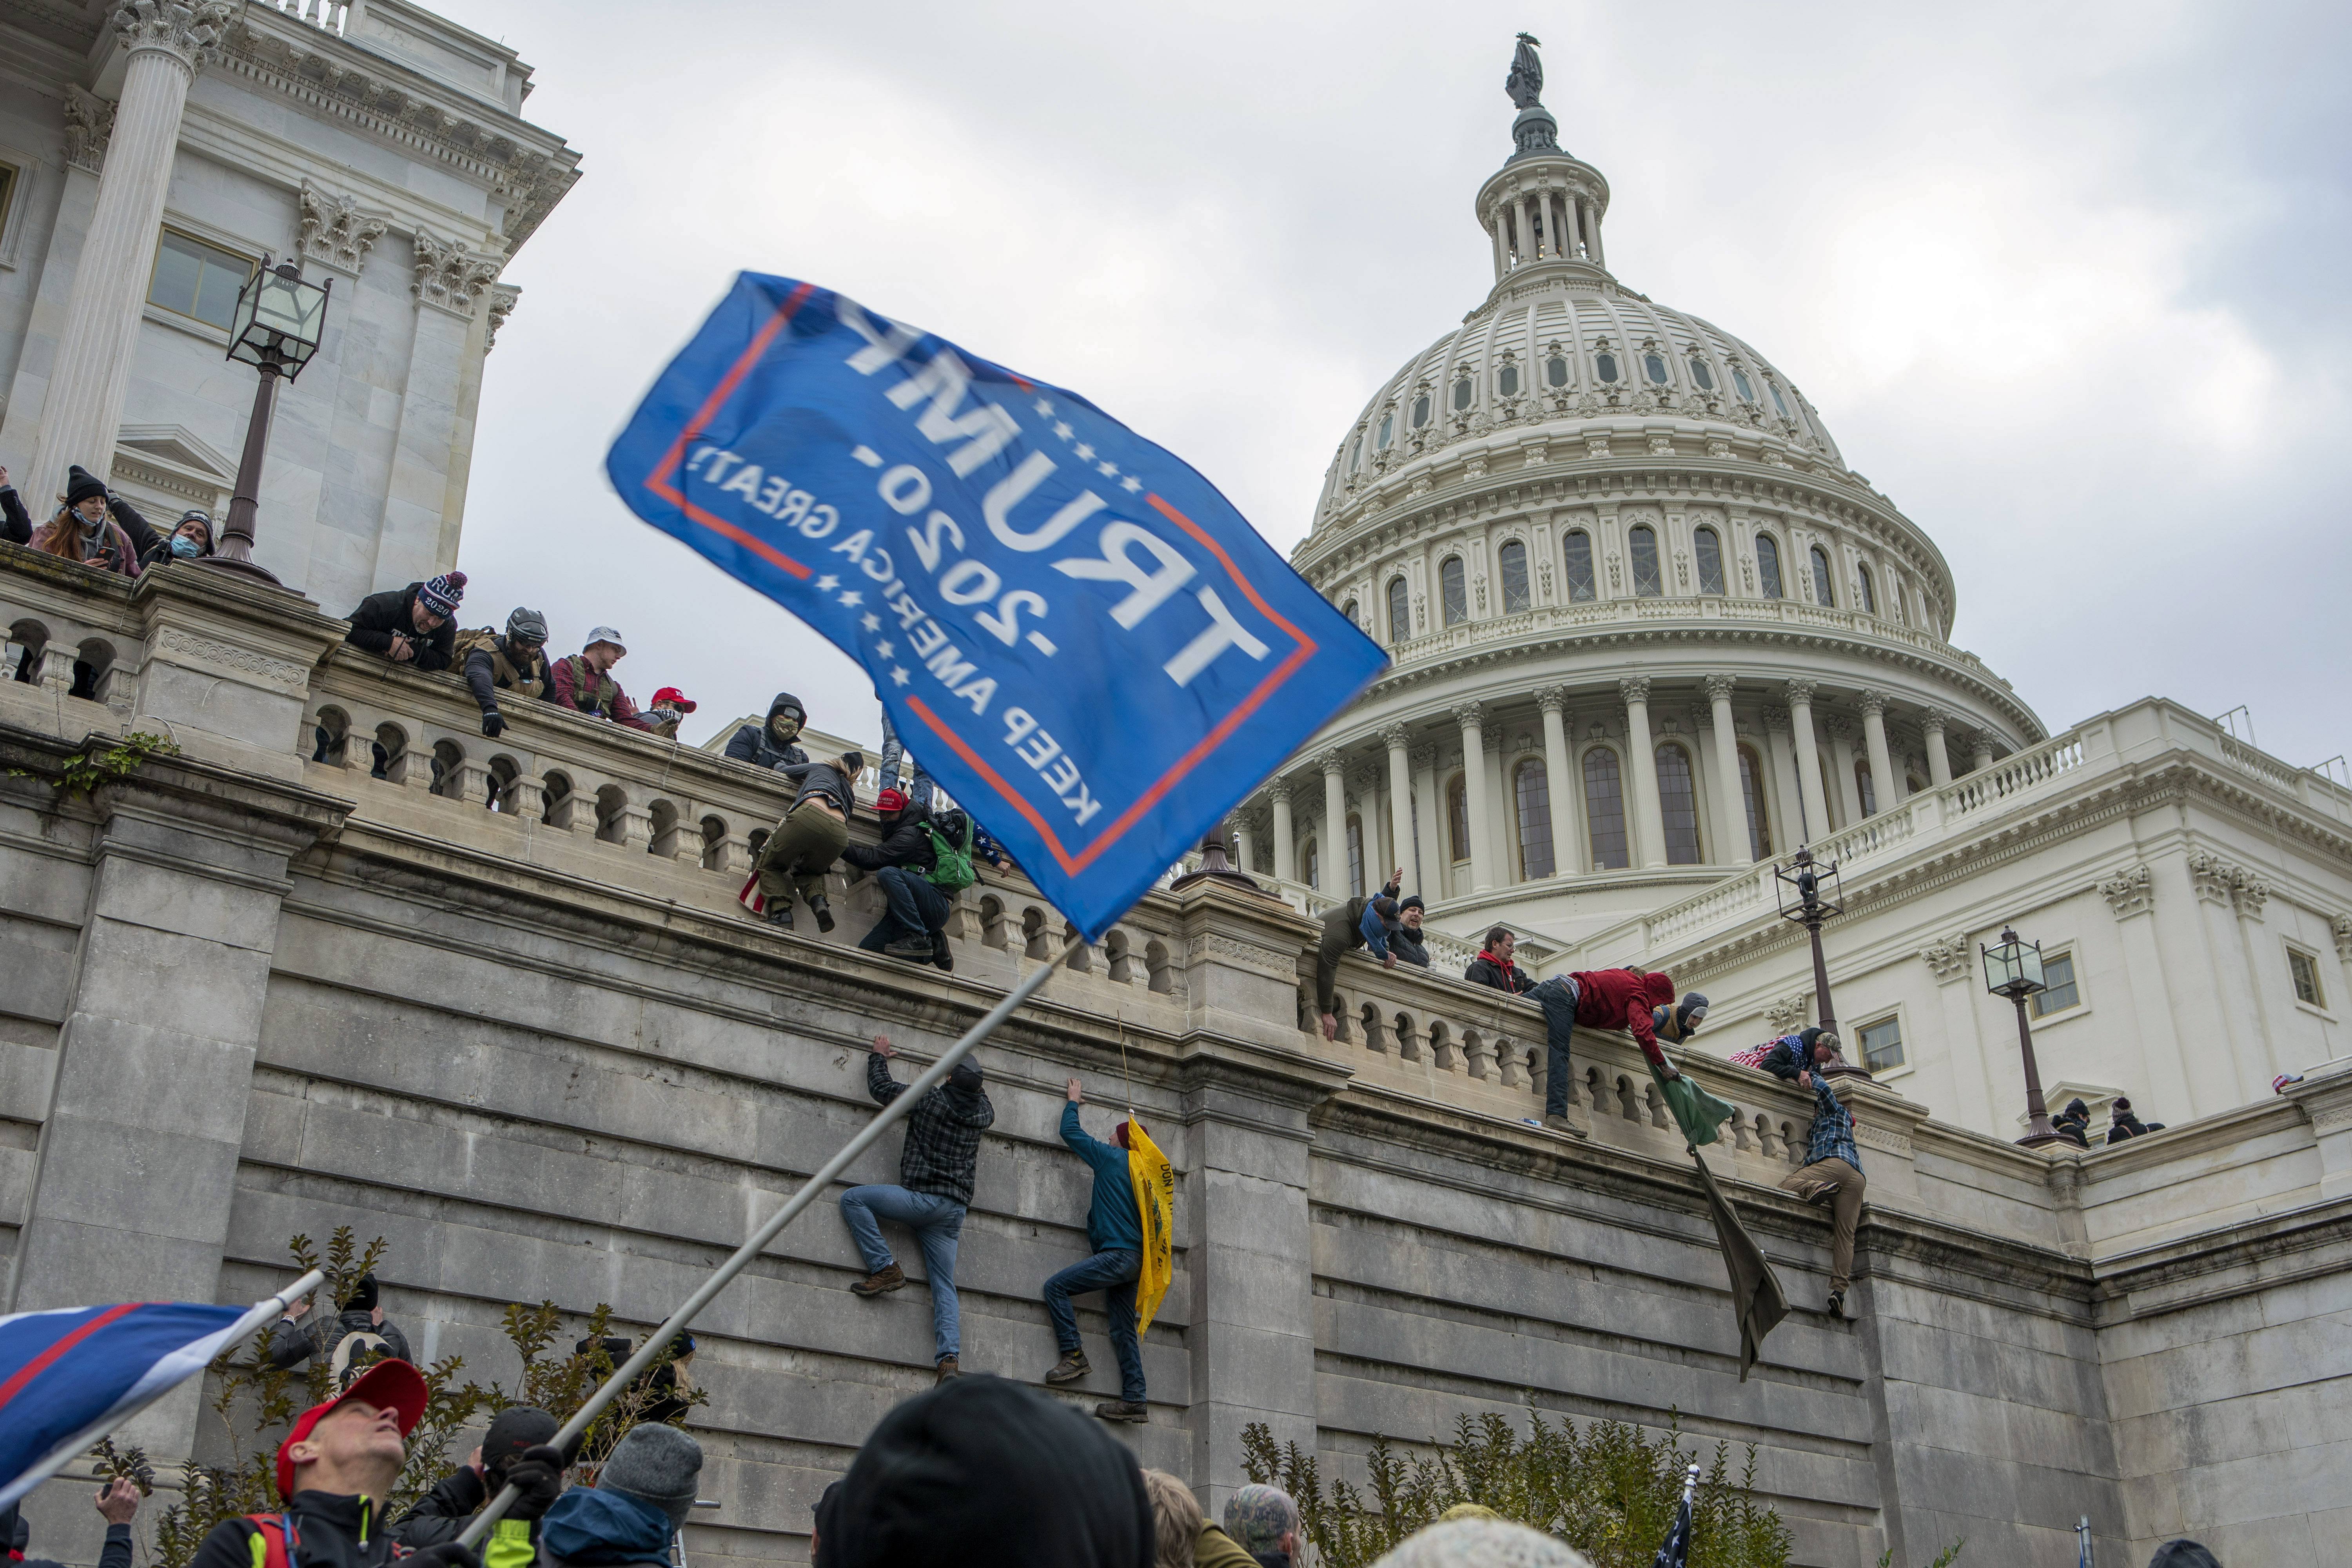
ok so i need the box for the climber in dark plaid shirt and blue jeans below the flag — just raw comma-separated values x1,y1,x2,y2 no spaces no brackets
842,1034,997,1382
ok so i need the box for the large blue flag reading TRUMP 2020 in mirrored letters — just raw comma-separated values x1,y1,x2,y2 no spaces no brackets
607,273,1388,940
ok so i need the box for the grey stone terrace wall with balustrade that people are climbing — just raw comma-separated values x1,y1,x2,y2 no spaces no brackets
0,550,2352,1568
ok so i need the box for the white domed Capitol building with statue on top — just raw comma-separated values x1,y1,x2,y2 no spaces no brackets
1237,47,2352,1136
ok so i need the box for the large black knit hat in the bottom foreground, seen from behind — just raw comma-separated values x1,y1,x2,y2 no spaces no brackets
818,1377,1157,1568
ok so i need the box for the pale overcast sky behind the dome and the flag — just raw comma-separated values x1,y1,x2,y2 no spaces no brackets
435,0,2352,764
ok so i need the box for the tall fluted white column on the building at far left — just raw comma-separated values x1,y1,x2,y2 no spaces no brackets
19,0,238,496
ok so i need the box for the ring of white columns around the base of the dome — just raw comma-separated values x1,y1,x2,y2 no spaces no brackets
1240,675,1994,898
